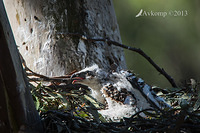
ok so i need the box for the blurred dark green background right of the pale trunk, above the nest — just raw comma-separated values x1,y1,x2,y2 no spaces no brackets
113,0,200,88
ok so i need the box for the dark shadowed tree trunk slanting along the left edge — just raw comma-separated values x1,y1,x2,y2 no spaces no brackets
0,1,42,133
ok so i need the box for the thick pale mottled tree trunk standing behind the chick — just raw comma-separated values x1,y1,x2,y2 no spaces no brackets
4,0,126,76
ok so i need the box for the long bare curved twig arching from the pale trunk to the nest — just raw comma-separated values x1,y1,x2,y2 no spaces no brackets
57,33,177,88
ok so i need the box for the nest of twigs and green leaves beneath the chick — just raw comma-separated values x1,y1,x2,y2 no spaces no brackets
31,78,200,133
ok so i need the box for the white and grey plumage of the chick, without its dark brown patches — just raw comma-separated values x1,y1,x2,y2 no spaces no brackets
72,64,170,121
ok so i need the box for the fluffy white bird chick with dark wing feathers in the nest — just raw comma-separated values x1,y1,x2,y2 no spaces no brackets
71,64,170,121
